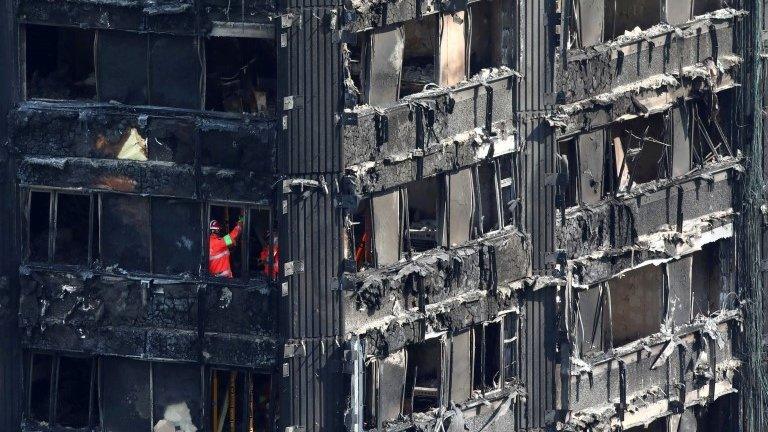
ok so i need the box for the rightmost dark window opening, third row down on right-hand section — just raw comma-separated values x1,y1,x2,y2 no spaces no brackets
691,240,733,317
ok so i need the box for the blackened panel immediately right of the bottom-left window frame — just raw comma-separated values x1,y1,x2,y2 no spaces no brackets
99,357,152,432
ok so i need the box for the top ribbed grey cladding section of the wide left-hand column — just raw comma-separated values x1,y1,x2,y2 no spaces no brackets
278,8,342,173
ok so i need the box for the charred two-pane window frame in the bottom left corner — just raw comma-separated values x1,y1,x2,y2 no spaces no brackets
23,350,101,432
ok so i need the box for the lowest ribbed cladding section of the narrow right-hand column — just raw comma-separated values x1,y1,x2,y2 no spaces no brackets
517,286,558,430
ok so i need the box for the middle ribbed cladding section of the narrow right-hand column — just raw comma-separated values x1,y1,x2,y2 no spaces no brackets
518,117,556,273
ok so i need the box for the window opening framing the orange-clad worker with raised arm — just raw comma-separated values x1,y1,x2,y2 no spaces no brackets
208,205,246,278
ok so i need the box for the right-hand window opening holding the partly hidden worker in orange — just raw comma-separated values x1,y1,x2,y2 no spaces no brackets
248,207,280,279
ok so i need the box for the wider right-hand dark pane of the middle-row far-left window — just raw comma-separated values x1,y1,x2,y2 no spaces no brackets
54,193,91,264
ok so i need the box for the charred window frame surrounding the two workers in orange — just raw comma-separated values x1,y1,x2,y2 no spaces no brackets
206,200,274,283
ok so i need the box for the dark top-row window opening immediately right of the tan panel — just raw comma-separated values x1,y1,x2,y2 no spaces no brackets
469,0,503,76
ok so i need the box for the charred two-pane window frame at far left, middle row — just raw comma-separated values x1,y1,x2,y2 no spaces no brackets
21,186,101,267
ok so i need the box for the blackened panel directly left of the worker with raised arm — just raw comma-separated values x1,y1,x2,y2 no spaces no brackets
151,198,202,274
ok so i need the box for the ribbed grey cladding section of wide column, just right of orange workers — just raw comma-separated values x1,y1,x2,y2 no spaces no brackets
280,177,342,338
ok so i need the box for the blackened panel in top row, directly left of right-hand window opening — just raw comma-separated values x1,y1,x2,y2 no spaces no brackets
149,35,202,109
